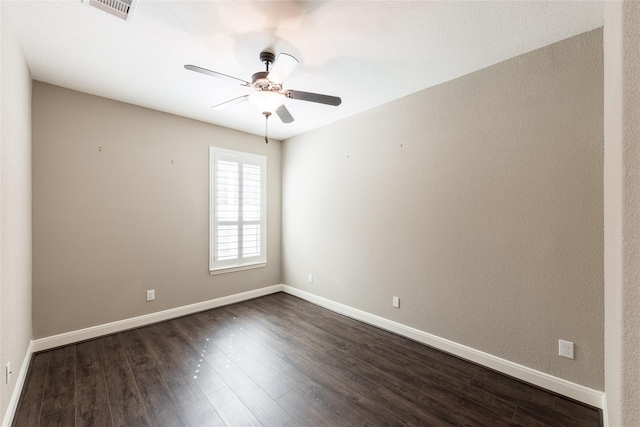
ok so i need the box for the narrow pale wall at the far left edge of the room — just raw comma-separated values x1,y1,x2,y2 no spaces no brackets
0,2,31,420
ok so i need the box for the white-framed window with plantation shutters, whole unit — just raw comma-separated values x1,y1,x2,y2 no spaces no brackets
209,147,267,274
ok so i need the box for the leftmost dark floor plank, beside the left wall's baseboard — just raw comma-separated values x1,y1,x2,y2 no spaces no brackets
12,351,51,427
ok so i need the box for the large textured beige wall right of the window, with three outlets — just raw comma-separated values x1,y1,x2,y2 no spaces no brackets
283,30,604,390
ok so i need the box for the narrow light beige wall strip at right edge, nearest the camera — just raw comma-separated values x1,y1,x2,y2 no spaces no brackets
604,1,640,427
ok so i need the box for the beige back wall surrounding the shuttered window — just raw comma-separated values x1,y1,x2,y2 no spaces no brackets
33,82,281,338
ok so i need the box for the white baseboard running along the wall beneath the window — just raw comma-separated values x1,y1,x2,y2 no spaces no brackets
32,285,282,352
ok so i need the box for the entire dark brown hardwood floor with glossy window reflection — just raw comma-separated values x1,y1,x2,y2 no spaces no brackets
13,293,600,427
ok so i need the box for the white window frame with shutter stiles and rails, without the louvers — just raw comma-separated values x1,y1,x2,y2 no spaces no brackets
209,146,267,275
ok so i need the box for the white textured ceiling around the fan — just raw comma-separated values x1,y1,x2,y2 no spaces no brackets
2,0,604,139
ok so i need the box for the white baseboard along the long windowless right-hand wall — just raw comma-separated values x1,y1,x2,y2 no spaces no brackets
283,285,604,409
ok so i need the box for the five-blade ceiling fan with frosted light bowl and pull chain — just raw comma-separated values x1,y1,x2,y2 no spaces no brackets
184,51,342,142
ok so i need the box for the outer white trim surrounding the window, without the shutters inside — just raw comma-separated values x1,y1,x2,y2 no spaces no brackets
209,146,267,275
